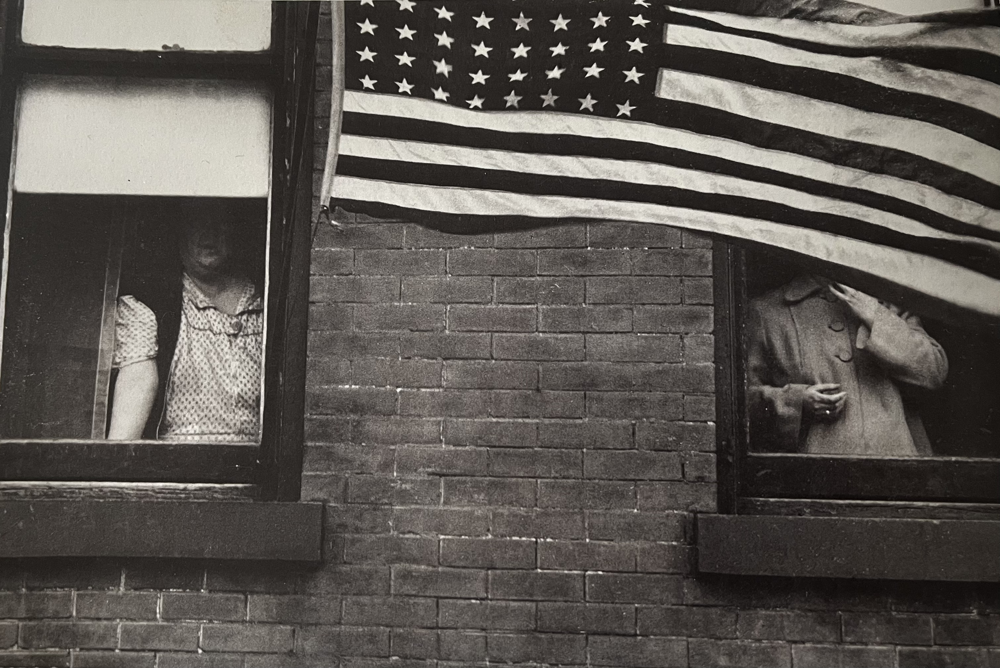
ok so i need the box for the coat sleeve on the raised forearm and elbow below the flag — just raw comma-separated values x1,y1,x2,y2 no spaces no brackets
856,304,948,390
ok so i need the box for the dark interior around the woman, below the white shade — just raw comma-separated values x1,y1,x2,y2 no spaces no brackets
0,194,267,439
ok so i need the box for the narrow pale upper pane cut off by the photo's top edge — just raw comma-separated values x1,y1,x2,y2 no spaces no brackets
21,0,271,51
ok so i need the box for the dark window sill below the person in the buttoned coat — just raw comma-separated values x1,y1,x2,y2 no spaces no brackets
697,515,1000,582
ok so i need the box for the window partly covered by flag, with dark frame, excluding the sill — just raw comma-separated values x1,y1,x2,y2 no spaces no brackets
716,243,1000,509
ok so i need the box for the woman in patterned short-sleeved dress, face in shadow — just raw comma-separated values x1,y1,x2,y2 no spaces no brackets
108,204,264,442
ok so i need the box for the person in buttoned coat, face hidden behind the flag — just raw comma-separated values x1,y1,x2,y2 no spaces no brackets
747,275,948,457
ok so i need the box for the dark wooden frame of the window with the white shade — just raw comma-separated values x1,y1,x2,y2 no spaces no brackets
0,0,318,506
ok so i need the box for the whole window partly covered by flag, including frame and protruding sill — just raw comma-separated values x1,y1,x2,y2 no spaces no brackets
698,244,1000,580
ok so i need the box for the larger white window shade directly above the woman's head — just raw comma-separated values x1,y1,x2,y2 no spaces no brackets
14,76,271,197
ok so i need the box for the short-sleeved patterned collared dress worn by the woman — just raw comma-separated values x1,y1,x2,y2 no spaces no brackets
114,275,264,442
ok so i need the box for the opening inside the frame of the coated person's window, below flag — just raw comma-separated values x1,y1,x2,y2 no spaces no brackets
745,251,1000,457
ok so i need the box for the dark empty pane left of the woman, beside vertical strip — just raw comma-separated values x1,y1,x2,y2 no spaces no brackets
0,198,111,438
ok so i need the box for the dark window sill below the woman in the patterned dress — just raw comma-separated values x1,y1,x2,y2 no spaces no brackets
0,500,323,561
